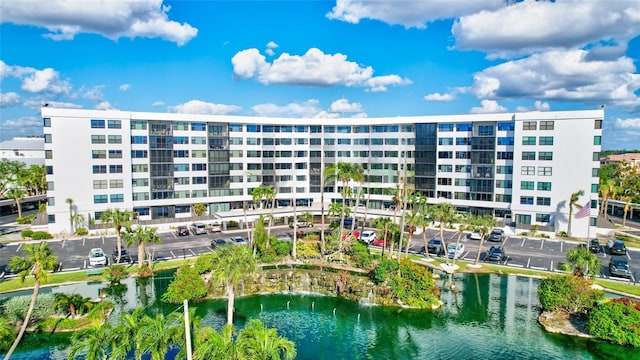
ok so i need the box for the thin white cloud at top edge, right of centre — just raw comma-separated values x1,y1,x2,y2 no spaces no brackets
326,0,504,29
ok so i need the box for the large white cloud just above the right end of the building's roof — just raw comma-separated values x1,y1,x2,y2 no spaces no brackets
471,50,640,108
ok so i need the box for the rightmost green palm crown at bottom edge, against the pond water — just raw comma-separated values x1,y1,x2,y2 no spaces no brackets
236,319,296,360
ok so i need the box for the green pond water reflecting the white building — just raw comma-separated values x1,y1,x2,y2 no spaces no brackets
5,274,640,360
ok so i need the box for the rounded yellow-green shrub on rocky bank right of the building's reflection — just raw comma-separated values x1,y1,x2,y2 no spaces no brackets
538,275,604,314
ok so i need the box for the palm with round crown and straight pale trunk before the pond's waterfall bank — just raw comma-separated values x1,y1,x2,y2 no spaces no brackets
211,245,256,325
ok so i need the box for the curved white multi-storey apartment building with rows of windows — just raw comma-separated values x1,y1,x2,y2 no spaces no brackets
42,107,604,237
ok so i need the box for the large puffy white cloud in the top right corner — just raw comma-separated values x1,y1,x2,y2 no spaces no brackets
452,0,640,56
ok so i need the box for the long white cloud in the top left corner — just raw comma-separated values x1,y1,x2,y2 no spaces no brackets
0,0,198,46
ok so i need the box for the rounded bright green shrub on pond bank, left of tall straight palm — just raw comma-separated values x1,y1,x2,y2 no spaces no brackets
162,265,207,304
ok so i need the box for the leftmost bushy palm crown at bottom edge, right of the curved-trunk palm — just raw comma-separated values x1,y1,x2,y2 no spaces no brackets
67,323,114,360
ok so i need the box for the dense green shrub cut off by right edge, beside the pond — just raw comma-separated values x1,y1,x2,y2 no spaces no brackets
587,299,640,347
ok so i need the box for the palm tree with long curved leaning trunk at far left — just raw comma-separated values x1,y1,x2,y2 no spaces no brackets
5,242,58,360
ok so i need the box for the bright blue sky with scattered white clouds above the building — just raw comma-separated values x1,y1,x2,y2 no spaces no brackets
0,0,640,149
